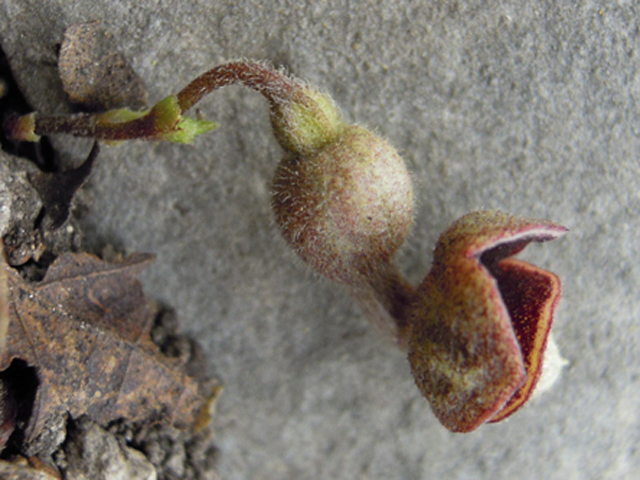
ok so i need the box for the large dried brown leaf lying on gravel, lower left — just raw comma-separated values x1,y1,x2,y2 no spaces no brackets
0,253,204,450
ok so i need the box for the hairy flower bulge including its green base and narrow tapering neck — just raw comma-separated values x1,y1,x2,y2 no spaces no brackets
262,72,414,342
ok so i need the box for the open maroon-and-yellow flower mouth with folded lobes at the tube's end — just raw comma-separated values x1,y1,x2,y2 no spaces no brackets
409,211,567,432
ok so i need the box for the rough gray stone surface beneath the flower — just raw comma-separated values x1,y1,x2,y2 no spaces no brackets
0,0,640,479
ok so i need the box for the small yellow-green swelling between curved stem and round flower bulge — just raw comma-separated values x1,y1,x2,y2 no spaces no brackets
271,86,344,154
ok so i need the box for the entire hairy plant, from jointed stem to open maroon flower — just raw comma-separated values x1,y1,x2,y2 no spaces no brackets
5,61,566,432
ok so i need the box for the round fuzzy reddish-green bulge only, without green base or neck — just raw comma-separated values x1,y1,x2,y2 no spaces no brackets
273,120,413,285
